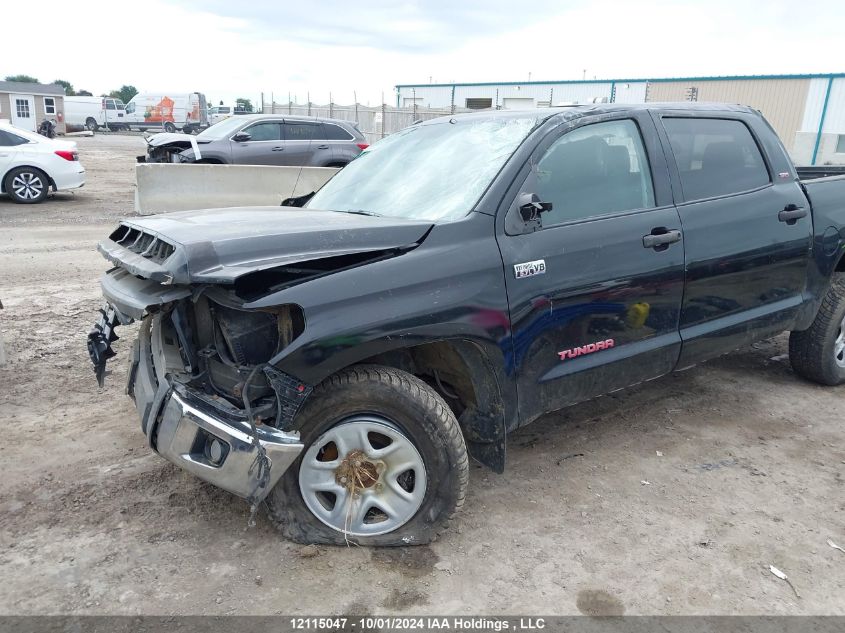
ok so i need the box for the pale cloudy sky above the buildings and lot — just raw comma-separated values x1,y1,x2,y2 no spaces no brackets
0,0,845,105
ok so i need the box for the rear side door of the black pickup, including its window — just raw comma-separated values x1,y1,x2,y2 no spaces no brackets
655,111,812,367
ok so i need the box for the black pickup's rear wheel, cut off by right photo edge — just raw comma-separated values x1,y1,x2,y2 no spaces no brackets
789,274,845,386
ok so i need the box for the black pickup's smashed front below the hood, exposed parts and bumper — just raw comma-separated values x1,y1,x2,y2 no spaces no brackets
88,268,311,506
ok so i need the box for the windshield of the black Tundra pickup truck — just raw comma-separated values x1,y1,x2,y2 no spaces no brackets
308,117,538,222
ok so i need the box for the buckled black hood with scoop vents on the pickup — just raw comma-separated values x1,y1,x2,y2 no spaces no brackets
98,207,432,284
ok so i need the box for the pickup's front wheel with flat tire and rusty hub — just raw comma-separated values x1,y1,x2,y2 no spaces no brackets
267,365,469,546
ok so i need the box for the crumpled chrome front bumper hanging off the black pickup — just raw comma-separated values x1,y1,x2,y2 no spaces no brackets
127,317,303,502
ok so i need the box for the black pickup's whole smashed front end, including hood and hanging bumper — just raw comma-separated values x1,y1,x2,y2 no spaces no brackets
88,207,430,510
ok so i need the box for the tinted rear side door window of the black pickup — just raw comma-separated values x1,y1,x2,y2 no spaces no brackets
663,118,771,200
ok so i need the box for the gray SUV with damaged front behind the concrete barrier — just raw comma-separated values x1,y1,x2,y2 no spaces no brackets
143,114,367,167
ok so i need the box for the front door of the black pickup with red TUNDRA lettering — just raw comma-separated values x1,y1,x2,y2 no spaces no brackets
498,113,684,423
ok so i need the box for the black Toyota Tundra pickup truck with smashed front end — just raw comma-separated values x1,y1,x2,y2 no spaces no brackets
88,104,845,545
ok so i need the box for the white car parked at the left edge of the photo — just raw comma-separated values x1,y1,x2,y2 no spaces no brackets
0,121,85,204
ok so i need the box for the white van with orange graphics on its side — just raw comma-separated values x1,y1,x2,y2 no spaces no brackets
126,92,208,134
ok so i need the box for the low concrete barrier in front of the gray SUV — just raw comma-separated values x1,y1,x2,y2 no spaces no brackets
135,163,337,215
